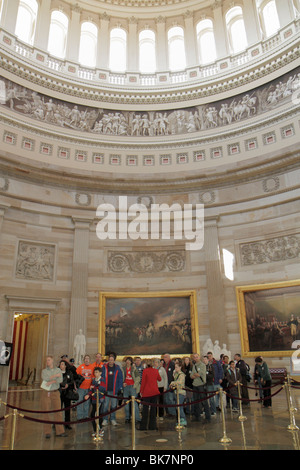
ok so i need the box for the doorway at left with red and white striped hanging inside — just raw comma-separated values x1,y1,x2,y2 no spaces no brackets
9,312,49,386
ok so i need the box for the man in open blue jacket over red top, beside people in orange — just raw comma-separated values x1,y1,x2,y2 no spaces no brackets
101,353,123,426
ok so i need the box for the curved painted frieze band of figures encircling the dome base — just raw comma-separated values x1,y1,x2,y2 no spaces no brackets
0,68,300,138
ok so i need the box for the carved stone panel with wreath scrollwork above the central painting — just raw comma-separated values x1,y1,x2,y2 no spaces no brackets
107,250,186,273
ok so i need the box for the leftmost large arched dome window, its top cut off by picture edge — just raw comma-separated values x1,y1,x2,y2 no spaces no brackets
15,0,38,45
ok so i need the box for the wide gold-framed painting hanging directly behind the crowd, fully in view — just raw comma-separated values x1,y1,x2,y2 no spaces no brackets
99,290,199,357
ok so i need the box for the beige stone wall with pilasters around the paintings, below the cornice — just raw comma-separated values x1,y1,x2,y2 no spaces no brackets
0,162,300,389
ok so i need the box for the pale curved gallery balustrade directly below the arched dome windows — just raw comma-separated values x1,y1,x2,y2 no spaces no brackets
0,18,300,97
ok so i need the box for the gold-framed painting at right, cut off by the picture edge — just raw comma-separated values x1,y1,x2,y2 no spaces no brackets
236,280,300,357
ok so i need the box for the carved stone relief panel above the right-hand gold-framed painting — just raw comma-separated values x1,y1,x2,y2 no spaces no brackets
239,235,300,266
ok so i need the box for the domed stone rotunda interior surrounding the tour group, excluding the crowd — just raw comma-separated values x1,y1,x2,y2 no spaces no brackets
0,0,300,455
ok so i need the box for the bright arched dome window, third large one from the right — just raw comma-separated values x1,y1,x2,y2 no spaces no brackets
196,19,217,64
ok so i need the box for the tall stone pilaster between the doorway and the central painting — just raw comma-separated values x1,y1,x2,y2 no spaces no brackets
69,218,92,356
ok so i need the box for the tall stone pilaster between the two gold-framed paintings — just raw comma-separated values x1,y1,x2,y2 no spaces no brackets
204,218,228,344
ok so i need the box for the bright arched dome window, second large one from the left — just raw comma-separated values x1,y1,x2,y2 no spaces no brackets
48,10,69,59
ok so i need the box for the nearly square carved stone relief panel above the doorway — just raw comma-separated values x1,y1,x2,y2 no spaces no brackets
15,240,56,281
